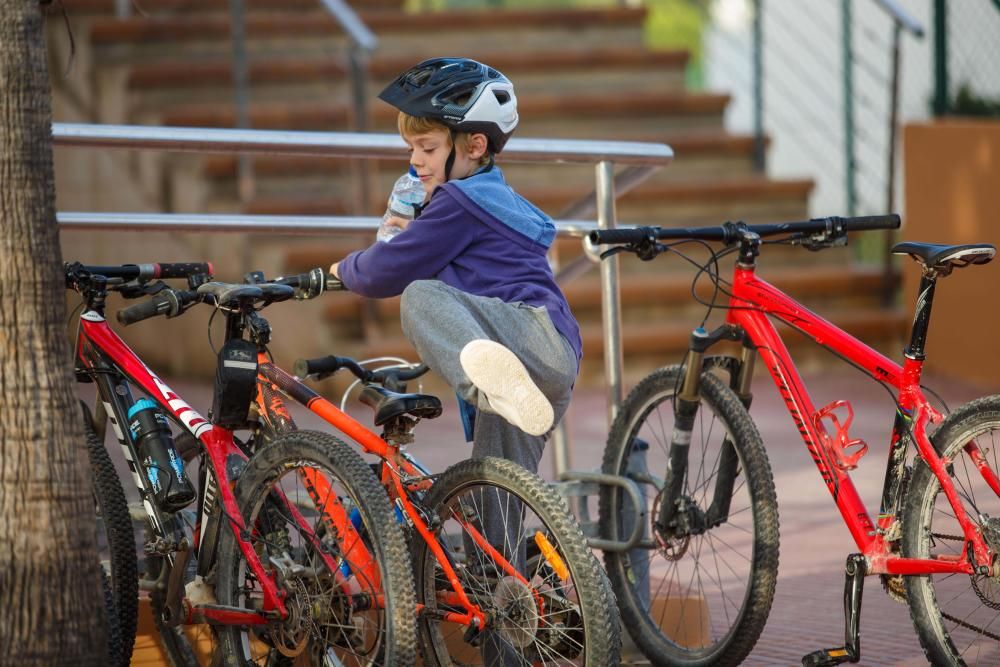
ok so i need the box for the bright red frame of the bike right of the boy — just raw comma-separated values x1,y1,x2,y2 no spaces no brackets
726,264,1000,575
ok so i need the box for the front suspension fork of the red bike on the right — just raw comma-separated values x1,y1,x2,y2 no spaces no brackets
656,324,755,530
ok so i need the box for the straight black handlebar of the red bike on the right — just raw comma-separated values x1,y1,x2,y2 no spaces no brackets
589,213,900,245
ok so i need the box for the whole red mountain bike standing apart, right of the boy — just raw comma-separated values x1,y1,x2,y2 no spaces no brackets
590,215,1000,665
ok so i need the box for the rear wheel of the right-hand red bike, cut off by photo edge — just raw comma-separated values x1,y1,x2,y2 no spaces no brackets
903,396,1000,665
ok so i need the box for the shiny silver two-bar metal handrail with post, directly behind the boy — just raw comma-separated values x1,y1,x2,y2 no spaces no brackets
52,123,673,479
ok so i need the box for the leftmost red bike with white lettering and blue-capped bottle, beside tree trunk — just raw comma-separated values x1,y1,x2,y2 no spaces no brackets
65,263,416,665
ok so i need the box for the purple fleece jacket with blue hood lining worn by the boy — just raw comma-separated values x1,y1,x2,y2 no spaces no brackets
338,167,582,362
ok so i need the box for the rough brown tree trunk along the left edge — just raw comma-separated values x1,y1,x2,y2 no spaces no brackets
0,0,108,667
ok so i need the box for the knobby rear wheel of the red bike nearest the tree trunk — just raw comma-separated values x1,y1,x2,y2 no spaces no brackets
216,431,417,667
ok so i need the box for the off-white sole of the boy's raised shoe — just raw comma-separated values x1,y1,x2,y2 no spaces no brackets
459,340,553,435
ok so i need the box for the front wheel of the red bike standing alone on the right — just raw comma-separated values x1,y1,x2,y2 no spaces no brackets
599,366,778,665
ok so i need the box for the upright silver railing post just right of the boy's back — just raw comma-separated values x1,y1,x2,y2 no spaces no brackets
596,160,624,427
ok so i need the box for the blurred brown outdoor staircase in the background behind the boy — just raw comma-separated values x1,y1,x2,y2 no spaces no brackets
50,0,904,382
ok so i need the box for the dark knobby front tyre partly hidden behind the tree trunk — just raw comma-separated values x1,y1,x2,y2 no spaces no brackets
81,402,139,667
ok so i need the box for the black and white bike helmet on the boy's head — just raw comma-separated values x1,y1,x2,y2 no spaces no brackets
379,58,517,153
